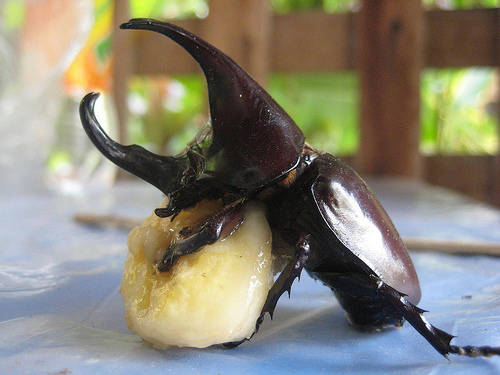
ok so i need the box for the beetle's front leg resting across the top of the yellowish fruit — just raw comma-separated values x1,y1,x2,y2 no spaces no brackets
158,201,245,272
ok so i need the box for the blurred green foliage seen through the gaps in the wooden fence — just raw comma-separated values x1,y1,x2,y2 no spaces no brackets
127,0,500,155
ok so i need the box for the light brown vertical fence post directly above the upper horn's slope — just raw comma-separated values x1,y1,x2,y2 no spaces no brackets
203,0,272,85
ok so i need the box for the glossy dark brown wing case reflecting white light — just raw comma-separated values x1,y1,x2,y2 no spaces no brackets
311,154,421,304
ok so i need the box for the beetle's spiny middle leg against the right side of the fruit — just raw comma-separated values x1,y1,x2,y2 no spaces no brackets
223,235,310,348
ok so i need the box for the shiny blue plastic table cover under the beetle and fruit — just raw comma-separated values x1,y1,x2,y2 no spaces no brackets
0,180,500,375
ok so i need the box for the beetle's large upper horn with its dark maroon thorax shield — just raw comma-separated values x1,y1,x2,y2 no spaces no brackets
120,19,304,187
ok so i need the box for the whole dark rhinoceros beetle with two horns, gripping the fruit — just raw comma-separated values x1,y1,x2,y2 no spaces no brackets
80,19,500,357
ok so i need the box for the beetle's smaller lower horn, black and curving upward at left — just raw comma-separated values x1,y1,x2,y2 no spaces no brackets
80,93,189,195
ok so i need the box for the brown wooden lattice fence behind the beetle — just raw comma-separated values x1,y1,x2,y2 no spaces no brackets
114,0,500,205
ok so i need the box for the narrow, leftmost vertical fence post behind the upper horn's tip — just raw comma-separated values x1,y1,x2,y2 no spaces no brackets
111,0,132,144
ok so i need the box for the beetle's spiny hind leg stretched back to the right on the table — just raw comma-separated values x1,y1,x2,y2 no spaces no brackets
377,281,500,357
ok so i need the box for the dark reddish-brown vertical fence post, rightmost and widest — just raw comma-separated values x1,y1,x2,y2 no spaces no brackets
358,0,423,177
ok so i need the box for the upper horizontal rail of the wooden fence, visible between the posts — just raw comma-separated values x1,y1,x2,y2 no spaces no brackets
132,9,500,75
